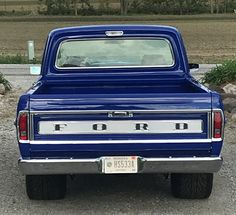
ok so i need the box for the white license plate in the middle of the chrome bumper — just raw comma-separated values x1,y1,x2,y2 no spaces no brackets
102,156,138,174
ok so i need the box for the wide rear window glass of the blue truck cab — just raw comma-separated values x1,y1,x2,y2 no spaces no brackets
55,38,175,69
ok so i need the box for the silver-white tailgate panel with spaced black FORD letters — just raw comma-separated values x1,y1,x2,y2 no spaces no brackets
39,120,203,135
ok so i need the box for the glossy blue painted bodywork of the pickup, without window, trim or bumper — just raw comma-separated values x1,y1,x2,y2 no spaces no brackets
17,25,223,159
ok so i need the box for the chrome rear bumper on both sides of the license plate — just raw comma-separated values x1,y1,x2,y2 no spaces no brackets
19,157,223,175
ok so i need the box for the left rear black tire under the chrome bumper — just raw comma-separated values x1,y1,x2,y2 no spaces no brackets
26,175,66,200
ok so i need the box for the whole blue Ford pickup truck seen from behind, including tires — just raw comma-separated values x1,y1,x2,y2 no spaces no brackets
16,25,224,200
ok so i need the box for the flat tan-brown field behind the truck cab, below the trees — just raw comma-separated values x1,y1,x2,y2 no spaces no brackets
0,14,236,63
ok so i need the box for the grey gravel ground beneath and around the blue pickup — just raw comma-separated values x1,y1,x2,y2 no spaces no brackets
0,77,236,215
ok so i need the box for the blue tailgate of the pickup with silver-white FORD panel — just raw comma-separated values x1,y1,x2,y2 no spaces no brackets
26,93,211,157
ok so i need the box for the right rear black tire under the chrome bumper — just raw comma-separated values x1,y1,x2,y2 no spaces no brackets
171,173,213,199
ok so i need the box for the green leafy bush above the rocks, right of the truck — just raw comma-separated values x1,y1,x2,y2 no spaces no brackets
202,60,236,86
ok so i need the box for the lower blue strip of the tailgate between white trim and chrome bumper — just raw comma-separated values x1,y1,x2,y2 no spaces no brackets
26,143,212,158
